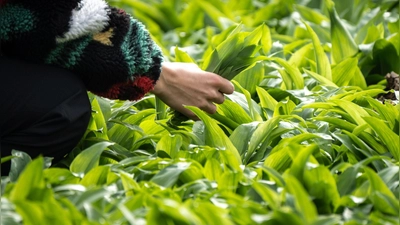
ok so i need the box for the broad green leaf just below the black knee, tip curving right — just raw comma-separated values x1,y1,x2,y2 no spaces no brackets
70,142,113,177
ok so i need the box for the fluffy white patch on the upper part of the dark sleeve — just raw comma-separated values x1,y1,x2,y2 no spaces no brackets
56,0,110,43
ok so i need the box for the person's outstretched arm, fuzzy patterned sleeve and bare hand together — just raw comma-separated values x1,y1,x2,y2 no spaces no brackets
0,0,233,118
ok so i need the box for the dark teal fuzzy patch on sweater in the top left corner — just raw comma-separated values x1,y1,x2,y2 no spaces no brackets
0,5,37,40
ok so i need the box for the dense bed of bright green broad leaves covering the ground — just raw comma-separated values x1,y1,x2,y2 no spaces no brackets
1,0,400,225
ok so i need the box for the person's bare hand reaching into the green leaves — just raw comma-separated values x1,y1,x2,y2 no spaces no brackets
152,63,234,120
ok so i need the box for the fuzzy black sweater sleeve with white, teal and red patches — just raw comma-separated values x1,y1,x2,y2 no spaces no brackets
0,0,163,100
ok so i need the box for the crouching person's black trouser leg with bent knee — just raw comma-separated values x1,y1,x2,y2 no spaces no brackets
0,57,91,175
